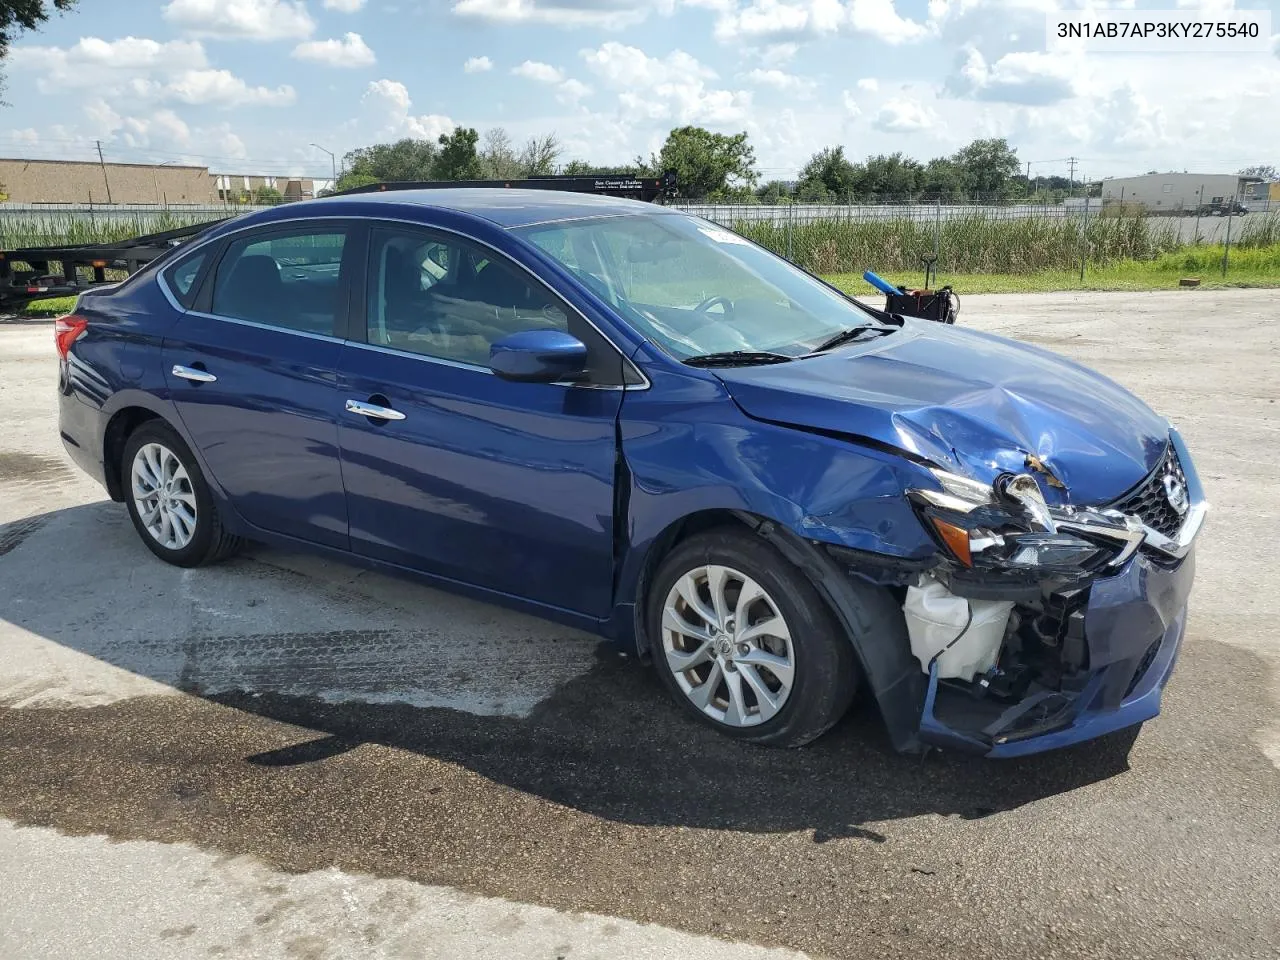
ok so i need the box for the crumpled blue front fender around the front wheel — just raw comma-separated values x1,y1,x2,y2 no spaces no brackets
616,370,937,750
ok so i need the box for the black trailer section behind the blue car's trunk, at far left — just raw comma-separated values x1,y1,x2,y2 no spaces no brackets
0,220,223,314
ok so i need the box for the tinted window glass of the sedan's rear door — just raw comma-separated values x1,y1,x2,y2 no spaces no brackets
210,228,346,337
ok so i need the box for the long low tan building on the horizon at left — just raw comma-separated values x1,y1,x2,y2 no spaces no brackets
0,159,316,205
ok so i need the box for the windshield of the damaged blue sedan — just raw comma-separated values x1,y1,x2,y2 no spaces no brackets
515,214,879,360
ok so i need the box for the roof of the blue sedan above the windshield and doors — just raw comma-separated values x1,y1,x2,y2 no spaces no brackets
308,187,676,228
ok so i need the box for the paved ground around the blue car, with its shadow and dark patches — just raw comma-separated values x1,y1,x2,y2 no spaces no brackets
0,291,1280,960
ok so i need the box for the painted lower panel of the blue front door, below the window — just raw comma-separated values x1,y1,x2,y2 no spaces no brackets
339,344,622,616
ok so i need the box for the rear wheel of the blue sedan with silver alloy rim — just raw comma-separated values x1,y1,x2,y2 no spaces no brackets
120,420,244,567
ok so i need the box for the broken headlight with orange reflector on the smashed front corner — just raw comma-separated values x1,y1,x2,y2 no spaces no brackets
909,470,1146,576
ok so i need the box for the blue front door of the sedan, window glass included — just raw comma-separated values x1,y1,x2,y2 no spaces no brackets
339,227,622,617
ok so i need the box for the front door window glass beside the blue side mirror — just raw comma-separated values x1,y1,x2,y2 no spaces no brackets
366,228,576,366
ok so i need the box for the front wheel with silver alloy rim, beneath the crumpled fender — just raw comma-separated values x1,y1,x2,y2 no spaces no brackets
648,527,858,746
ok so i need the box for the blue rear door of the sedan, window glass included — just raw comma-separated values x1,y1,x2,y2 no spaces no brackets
163,220,362,548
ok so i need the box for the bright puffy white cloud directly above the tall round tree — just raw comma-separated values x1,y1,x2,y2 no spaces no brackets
581,41,751,127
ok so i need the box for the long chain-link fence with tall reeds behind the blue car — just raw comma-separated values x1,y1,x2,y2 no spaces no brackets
0,198,1280,276
